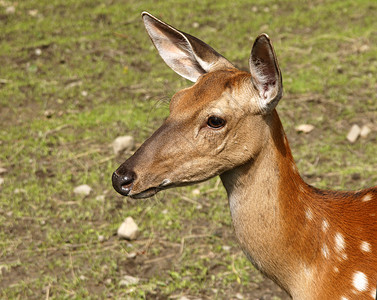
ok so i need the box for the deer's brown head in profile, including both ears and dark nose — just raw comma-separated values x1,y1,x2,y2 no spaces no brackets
112,12,282,198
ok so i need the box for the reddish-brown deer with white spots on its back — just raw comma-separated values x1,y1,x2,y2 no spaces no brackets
112,12,377,300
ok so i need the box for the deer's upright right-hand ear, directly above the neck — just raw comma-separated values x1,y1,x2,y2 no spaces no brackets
249,34,283,113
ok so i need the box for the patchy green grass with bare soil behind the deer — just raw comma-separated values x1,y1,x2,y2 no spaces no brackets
0,0,377,299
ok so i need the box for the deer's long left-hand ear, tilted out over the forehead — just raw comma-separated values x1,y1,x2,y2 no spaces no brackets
142,12,233,82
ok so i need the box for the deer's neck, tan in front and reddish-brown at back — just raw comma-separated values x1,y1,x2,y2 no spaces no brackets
221,111,319,295
